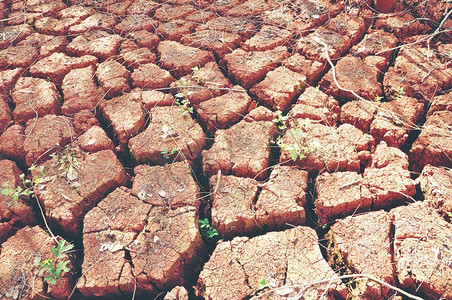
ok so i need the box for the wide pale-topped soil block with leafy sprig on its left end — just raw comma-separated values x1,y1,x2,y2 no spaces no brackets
280,119,375,171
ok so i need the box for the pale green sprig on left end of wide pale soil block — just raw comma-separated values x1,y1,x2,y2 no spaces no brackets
276,127,320,161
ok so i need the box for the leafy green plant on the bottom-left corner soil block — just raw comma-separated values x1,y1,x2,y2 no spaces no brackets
39,240,74,285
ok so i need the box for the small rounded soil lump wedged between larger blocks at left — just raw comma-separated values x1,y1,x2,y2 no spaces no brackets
77,125,115,153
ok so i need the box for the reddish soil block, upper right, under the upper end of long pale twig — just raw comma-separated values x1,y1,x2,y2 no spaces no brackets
294,27,352,63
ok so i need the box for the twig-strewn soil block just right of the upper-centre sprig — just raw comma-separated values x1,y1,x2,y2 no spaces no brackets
171,62,231,104
